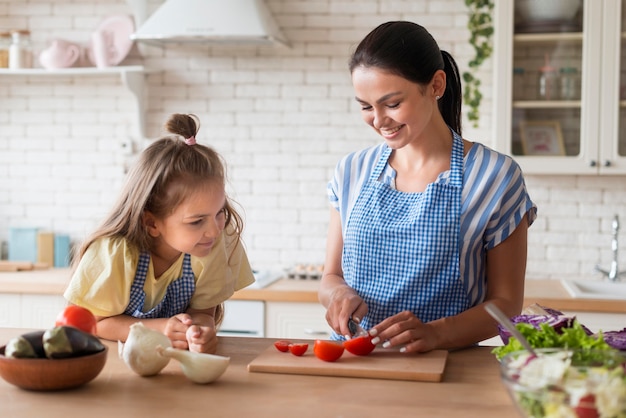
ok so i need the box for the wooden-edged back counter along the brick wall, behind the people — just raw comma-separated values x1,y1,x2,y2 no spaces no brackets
0,269,626,313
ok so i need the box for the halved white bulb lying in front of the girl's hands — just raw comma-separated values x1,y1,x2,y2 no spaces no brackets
157,347,230,383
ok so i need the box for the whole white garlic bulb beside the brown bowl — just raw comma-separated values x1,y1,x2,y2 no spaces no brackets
117,322,172,376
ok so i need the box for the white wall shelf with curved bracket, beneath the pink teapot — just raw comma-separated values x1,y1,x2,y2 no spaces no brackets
0,65,146,139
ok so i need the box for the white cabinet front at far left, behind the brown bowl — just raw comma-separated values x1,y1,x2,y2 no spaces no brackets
0,294,67,329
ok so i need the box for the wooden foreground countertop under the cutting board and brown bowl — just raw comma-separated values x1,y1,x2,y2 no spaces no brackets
0,328,517,418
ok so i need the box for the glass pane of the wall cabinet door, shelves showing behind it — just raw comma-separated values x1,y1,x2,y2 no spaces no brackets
511,0,585,156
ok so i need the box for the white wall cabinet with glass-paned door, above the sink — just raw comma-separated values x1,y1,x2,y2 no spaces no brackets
493,0,626,175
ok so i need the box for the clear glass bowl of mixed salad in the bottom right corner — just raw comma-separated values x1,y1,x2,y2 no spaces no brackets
500,348,626,418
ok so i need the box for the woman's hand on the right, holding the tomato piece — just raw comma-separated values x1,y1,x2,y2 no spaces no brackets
370,311,437,353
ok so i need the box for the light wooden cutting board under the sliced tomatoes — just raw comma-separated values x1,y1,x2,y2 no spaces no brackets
248,343,448,382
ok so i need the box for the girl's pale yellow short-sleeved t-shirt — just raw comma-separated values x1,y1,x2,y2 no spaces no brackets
63,232,254,316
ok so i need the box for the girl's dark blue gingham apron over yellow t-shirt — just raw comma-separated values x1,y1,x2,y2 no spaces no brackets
124,252,196,318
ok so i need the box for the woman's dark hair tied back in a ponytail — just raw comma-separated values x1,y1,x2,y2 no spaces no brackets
350,21,462,135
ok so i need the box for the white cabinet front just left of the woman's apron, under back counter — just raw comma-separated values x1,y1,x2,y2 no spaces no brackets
265,302,332,339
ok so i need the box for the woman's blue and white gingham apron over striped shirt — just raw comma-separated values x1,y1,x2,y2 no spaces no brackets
342,132,470,338
